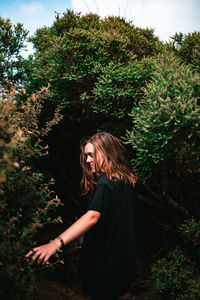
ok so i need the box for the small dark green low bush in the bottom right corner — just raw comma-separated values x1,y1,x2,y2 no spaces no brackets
152,247,200,300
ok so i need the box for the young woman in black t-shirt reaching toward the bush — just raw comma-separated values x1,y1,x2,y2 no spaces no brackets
27,132,136,300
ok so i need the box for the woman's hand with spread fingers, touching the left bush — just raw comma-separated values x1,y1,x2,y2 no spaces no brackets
26,239,60,265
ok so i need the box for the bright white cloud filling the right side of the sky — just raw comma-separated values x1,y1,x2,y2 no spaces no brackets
71,0,200,41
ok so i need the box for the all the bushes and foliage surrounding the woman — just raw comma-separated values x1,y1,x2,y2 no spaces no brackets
0,10,200,300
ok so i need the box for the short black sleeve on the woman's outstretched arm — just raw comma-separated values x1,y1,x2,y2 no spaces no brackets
88,183,111,213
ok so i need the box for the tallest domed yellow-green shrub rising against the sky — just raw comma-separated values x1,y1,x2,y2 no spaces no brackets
31,11,162,105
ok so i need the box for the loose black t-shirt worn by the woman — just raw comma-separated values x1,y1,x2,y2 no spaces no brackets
80,175,136,291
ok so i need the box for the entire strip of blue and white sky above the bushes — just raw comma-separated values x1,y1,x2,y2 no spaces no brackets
0,0,200,54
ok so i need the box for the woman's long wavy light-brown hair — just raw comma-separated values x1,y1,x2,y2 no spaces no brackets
80,132,137,194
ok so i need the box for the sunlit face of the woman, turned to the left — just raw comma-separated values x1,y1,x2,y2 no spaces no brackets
85,143,103,173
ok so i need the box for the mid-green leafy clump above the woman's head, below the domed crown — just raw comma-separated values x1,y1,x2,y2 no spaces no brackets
88,59,153,119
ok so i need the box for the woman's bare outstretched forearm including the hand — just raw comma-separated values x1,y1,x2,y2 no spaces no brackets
26,210,101,265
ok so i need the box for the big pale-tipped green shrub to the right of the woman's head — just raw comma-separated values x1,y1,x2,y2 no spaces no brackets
127,53,200,181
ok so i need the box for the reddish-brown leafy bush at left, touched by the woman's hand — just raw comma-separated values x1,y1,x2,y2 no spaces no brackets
0,83,61,300
